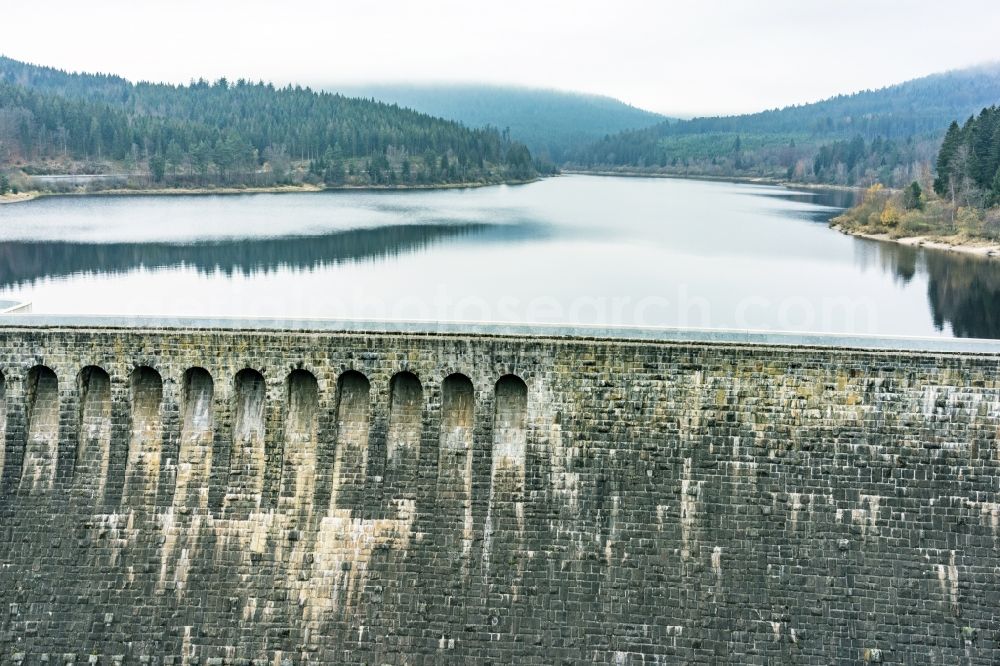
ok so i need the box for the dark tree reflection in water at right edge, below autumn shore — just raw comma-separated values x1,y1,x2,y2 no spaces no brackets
860,241,1000,339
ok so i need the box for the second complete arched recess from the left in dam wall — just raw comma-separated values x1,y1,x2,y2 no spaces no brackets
73,365,111,501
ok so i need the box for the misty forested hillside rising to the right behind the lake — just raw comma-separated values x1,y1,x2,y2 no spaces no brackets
573,64,1000,186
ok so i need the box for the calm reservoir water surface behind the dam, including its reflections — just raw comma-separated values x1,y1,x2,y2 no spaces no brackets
0,176,1000,338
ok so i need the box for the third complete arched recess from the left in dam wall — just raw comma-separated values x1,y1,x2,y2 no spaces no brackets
122,366,163,508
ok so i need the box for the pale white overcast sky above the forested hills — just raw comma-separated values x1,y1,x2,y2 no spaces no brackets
0,0,1000,115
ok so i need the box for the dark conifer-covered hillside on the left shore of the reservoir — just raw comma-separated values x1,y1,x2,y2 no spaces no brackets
0,58,536,191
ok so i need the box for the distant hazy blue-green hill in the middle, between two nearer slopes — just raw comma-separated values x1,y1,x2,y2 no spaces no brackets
329,84,670,164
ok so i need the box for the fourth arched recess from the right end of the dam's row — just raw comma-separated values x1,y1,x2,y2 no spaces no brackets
330,370,371,510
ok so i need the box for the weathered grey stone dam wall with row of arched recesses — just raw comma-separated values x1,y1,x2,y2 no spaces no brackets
0,328,1000,666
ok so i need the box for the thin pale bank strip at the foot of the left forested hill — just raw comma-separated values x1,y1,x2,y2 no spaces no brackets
0,176,542,204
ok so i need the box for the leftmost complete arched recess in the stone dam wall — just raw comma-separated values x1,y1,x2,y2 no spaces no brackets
20,365,59,493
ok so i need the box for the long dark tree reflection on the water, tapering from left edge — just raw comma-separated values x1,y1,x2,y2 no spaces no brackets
0,223,540,288
